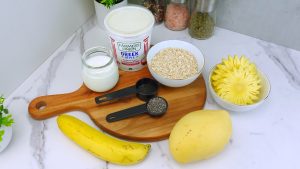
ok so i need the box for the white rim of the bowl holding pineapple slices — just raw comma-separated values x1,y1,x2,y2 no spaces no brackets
208,63,271,107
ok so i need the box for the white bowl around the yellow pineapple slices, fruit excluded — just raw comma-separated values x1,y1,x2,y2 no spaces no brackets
208,67,271,112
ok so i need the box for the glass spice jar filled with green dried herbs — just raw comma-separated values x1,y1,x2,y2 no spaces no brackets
189,0,217,39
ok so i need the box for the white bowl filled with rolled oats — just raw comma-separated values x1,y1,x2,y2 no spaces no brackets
147,40,204,87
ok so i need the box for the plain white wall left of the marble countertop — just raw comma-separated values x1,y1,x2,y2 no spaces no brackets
0,0,94,96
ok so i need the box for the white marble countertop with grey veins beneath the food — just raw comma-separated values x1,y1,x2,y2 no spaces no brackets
0,18,300,169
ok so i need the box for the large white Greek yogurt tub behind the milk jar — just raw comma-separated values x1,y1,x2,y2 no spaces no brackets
104,6,154,71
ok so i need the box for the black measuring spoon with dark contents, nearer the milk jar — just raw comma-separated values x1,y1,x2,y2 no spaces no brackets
95,78,158,104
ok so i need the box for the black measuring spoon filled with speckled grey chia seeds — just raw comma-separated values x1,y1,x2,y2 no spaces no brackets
106,96,168,123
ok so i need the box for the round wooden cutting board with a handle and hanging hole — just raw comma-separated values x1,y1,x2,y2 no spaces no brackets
28,67,206,141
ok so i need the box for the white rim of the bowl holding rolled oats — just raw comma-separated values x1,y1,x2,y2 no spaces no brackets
146,40,206,81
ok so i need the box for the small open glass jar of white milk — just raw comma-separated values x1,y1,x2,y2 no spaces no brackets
81,46,119,92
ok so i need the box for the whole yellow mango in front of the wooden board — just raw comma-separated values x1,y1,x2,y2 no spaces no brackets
169,110,232,163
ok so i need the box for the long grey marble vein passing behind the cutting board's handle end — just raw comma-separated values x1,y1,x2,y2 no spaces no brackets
11,26,83,169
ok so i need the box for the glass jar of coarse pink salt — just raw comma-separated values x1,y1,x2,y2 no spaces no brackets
165,0,190,31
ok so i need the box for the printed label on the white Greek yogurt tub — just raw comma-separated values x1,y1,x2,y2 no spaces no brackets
110,36,150,71
